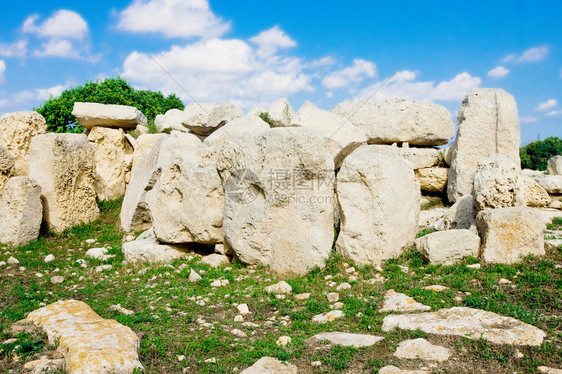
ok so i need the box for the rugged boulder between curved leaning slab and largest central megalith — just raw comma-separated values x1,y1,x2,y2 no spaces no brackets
146,148,224,244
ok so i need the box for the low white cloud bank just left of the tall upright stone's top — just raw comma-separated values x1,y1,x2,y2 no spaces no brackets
357,70,482,101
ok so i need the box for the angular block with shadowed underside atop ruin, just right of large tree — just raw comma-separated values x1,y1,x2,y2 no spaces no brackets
182,103,244,136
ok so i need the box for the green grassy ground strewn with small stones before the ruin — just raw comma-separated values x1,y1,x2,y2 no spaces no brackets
0,202,562,374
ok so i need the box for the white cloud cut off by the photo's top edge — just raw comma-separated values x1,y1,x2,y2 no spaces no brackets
117,0,230,38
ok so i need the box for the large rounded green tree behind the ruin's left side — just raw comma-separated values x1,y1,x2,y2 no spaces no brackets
35,77,184,132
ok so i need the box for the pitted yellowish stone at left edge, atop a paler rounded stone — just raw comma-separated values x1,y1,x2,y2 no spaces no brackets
0,112,47,176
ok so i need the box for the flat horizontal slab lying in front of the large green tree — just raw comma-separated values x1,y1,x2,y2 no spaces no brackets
72,102,147,129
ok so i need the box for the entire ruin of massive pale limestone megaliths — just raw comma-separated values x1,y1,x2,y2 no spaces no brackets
0,88,562,277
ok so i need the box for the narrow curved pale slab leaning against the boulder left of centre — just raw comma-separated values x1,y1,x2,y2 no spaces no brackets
120,131,202,231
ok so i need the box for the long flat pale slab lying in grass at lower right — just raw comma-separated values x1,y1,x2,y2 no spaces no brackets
382,307,546,346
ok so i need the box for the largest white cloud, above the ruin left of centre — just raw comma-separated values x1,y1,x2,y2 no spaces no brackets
122,32,312,108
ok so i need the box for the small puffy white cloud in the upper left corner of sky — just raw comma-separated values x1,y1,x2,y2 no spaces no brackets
23,9,88,40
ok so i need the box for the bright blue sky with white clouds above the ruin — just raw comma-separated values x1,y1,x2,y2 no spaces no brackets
0,0,562,144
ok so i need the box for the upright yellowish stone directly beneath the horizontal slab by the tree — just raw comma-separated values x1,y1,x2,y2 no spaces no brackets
88,126,133,201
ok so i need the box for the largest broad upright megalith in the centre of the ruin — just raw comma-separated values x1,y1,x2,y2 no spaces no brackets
215,127,335,276
